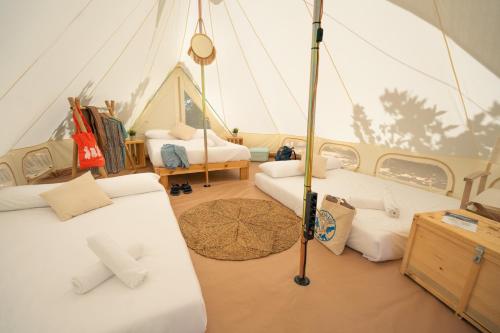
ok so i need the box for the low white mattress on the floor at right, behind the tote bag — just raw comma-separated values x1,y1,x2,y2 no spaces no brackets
255,169,460,261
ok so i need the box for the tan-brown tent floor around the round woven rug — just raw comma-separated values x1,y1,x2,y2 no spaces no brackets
44,163,476,333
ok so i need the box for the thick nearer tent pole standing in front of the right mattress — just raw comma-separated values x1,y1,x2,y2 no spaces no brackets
294,0,323,286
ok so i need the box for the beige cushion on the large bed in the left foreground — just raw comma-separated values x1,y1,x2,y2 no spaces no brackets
40,172,113,221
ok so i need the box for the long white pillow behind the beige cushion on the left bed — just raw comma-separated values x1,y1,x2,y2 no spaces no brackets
0,172,165,212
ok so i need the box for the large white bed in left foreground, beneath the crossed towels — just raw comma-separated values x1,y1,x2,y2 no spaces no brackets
0,174,206,333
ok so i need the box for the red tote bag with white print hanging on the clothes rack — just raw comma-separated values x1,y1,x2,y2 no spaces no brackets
73,107,105,169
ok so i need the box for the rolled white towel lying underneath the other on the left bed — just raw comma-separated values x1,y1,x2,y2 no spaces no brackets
71,244,143,295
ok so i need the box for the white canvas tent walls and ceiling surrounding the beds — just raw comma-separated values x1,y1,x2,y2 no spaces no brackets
0,0,500,196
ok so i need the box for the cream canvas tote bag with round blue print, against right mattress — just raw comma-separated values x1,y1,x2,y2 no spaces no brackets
314,195,356,255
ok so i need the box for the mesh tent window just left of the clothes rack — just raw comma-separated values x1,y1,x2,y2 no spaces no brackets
22,147,54,183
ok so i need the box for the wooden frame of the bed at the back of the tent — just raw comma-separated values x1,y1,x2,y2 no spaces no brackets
154,160,250,189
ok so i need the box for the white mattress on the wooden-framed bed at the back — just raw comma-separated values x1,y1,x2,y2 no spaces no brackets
146,139,250,167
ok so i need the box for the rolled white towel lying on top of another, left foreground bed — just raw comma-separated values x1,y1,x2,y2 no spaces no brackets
87,233,148,288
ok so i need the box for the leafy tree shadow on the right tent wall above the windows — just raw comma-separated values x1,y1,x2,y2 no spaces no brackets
352,89,500,159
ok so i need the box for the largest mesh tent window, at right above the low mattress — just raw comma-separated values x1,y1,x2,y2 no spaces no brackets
374,153,455,195
